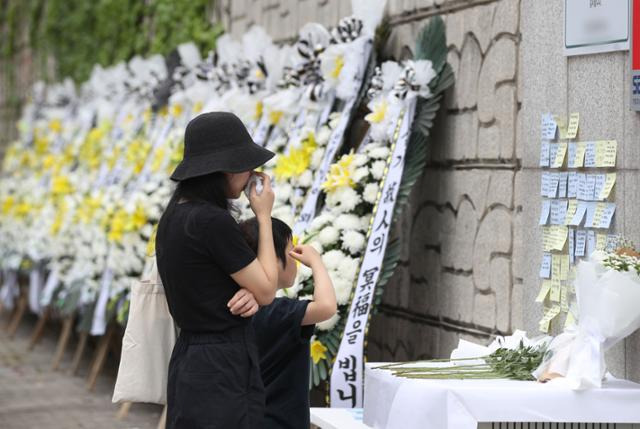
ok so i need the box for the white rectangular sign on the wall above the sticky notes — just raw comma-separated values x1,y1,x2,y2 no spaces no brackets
564,0,631,55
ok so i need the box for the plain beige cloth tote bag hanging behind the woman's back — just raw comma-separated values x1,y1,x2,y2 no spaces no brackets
112,256,176,404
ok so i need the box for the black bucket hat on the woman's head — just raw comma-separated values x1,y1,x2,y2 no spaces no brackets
171,112,275,181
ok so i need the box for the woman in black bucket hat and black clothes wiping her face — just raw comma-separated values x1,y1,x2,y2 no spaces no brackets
156,112,278,429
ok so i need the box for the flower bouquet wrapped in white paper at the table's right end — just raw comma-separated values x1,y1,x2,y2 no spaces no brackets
535,242,640,389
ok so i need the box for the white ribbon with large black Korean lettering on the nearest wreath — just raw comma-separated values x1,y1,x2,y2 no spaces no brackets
331,98,416,408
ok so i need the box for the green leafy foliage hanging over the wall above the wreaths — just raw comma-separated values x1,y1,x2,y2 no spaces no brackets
0,0,223,82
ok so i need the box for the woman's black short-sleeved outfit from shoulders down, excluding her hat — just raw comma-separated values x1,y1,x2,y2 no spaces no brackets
156,202,264,429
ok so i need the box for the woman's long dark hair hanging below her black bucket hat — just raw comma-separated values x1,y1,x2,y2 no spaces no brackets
156,173,232,258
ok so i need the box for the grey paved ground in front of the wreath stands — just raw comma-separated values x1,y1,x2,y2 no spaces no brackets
0,313,162,429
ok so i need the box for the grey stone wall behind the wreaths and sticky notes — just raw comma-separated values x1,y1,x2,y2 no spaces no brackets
224,0,640,380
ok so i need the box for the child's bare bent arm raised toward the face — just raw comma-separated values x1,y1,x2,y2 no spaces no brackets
290,246,337,326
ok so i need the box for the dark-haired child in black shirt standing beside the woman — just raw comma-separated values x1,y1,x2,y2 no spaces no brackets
229,218,337,429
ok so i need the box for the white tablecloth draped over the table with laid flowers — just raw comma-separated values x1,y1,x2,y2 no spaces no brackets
364,363,640,429
